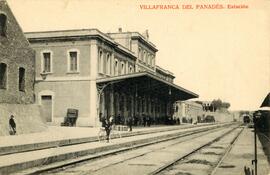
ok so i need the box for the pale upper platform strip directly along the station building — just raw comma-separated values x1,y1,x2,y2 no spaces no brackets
0,124,201,155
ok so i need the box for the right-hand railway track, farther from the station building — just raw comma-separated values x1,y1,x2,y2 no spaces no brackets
153,127,244,175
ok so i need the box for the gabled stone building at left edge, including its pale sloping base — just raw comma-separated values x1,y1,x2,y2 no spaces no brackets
0,0,44,135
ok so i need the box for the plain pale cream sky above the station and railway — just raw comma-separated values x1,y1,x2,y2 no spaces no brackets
7,0,270,110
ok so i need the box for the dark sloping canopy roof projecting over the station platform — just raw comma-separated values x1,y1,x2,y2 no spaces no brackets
97,72,199,101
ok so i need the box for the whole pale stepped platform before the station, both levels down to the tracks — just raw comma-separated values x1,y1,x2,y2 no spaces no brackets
0,124,213,174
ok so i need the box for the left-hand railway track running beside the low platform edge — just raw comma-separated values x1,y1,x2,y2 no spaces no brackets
18,125,238,174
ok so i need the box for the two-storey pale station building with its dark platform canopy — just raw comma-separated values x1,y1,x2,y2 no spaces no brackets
25,29,198,126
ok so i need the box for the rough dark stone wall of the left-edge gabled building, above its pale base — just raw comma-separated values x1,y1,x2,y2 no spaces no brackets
0,1,35,104
